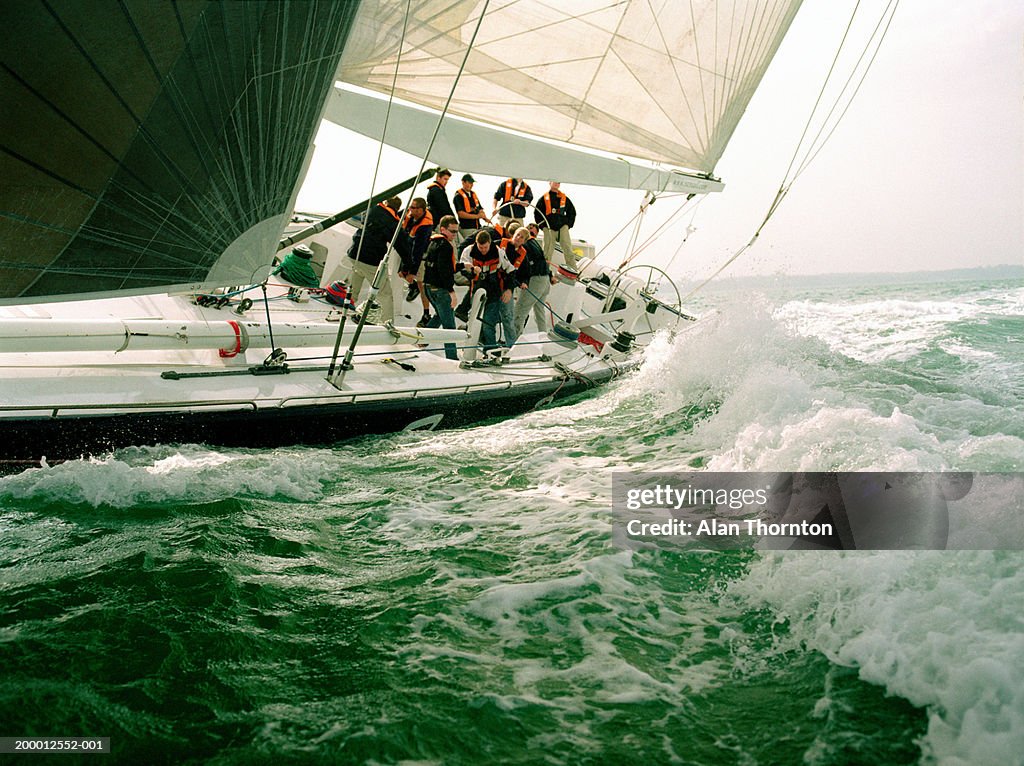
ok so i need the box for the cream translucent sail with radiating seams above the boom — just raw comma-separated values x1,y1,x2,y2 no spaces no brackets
339,0,800,172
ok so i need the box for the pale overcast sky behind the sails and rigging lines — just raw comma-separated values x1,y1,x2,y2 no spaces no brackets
298,0,1024,278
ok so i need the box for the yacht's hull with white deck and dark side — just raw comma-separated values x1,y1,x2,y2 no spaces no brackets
0,236,692,460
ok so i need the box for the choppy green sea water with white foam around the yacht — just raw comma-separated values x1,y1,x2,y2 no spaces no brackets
0,282,1024,766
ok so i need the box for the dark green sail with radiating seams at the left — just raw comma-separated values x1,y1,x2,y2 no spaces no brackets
0,0,357,302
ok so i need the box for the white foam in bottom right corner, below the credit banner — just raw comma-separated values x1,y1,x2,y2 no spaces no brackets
729,551,1024,766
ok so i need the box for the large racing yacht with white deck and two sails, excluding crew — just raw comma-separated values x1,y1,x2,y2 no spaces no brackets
0,0,800,460
